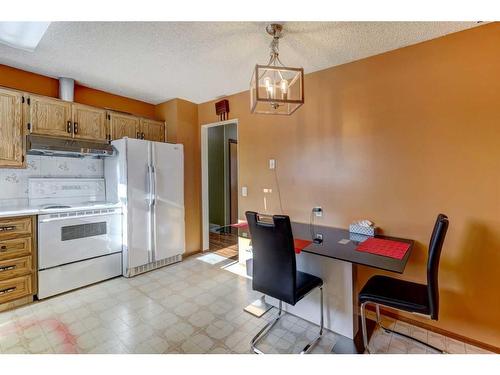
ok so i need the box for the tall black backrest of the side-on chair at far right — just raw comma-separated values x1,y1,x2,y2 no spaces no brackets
427,214,448,320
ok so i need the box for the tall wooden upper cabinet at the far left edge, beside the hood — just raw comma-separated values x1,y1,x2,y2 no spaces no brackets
0,89,25,168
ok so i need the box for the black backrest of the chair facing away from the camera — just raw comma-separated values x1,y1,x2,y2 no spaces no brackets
245,211,297,304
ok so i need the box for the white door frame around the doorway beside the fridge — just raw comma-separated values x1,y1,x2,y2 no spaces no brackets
201,119,240,251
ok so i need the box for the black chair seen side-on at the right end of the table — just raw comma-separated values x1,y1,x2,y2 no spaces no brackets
359,214,448,353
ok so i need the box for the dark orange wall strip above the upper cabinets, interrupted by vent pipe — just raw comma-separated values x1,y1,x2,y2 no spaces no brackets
0,65,155,118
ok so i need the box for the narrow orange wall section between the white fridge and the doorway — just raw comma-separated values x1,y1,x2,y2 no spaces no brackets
156,99,201,255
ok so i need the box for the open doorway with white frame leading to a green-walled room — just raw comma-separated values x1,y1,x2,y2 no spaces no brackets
201,120,238,260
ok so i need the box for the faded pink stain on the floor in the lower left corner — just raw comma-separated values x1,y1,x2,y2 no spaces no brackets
0,319,78,353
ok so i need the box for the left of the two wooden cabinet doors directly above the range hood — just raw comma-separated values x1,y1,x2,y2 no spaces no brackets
29,95,73,137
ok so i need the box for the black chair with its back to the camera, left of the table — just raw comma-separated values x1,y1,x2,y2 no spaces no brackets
246,211,323,354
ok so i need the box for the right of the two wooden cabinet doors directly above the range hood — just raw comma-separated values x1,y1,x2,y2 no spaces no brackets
72,103,107,142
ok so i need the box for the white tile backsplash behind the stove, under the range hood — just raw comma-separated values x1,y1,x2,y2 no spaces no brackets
0,155,104,199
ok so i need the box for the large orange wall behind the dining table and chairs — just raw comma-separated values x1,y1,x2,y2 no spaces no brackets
198,23,500,347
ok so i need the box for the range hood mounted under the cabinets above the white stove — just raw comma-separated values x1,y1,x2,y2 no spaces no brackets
26,134,115,158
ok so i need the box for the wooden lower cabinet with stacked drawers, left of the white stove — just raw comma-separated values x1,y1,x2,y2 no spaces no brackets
0,216,37,311
